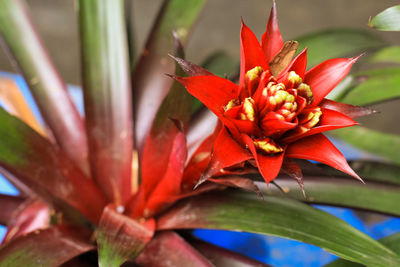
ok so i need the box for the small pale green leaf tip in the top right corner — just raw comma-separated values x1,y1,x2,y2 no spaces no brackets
368,5,400,31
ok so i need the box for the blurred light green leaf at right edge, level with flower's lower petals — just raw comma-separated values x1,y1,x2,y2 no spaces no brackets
332,126,400,165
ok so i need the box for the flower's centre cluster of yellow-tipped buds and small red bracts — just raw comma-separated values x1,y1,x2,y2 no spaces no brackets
224,66,322,154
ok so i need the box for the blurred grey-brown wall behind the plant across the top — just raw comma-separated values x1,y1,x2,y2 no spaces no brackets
0,0,400,133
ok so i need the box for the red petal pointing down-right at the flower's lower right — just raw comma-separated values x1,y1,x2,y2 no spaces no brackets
286,134,362,181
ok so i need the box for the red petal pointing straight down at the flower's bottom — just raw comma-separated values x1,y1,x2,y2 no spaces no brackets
242,134,284,183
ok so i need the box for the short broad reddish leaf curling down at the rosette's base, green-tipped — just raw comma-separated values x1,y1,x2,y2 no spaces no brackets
97,205,155,267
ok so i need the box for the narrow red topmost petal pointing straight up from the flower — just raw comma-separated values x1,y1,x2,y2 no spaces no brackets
261,1,283,62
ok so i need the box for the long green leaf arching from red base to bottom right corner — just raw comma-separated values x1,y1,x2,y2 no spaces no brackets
157,191,400,266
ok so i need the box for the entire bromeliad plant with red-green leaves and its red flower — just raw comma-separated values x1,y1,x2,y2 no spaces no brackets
0,0,400,266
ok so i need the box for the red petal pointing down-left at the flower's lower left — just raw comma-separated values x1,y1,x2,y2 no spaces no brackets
196,127,252,186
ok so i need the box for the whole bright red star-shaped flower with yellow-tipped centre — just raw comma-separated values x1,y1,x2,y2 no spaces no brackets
175,4,360,186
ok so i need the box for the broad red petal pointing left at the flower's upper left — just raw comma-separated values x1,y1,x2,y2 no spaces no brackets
174,76,239,118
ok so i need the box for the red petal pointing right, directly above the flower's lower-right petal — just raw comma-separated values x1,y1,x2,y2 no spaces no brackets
283,108,358,143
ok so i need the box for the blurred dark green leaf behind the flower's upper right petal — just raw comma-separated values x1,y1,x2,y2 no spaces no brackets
295,29,386,68
